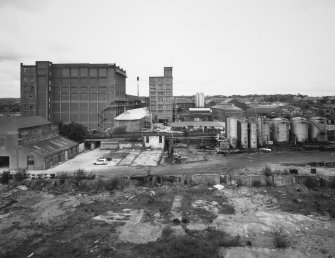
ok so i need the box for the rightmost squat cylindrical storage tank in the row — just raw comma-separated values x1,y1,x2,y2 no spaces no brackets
308,117,328,142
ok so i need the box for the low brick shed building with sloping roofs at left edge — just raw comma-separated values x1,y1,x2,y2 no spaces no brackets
0,117,78,170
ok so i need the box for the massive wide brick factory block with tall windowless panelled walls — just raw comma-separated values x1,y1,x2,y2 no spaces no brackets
21,61,140,130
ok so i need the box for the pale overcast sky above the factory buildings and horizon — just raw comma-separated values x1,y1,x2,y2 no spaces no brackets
0,0,335,97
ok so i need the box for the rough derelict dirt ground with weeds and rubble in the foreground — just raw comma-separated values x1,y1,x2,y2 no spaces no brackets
0,180,335,258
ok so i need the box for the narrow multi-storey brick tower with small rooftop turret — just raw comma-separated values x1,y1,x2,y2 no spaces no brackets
149,67,173,123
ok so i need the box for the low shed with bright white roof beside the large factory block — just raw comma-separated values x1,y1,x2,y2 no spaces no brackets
114,108,152,132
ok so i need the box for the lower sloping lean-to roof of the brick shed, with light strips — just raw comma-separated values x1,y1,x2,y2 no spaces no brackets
22,136,78,157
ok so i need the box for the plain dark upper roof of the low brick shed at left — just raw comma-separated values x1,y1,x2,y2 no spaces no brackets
0,116,51,133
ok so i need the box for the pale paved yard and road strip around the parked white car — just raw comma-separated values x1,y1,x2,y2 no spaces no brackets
29,149,335,177
